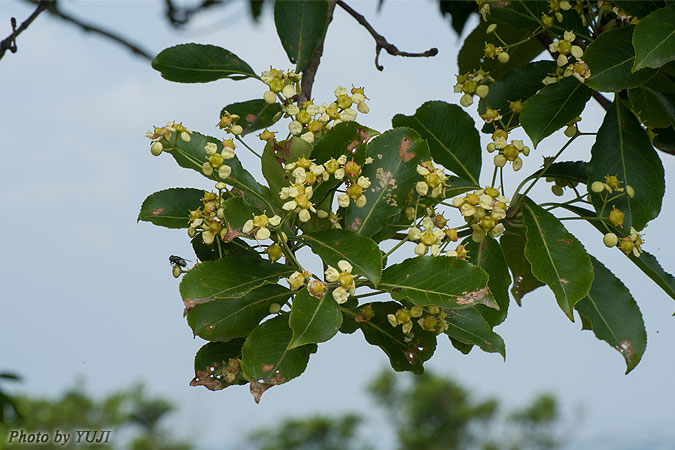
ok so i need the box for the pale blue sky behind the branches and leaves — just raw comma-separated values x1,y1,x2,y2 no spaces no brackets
0,0,675,449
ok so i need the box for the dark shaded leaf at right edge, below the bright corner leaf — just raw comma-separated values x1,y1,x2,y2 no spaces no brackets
628,72,675,128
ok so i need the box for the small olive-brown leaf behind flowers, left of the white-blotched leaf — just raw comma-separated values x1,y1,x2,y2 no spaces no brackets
261,137,312,206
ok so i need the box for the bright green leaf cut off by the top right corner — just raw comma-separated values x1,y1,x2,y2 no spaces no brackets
633,5,675,71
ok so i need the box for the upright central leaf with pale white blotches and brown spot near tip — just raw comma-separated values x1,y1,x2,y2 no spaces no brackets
344,128,429,236
